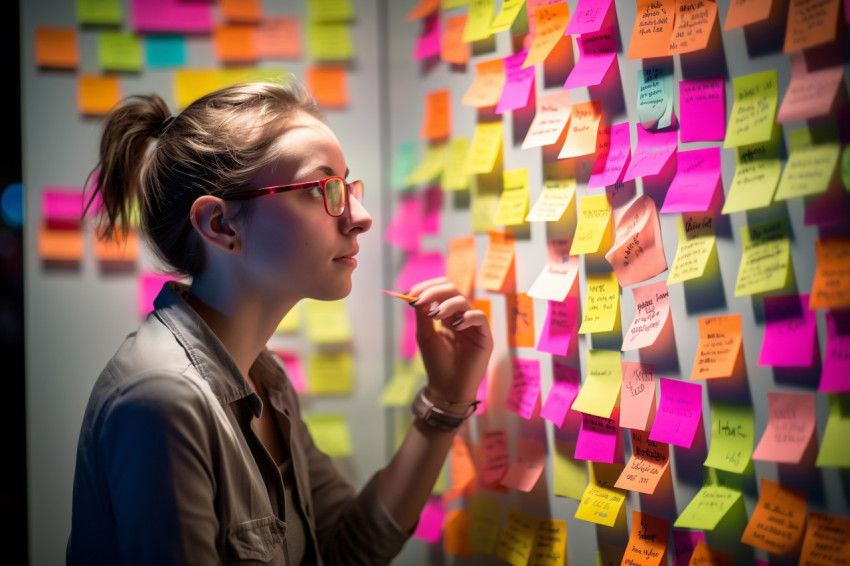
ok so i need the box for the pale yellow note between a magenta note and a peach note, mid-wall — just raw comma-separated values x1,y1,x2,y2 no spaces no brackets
571,350,623,419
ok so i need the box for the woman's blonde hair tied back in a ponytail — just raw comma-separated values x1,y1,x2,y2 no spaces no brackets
86,76,322,276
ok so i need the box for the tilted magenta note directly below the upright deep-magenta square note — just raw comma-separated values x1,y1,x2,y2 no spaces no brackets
661,147,721,212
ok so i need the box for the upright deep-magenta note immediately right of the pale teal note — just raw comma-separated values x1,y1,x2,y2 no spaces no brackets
679,77,726,142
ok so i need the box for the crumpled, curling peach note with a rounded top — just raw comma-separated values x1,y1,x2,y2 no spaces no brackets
605,195,667,287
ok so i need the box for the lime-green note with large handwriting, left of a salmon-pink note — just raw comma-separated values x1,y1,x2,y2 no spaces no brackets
705,401,755,474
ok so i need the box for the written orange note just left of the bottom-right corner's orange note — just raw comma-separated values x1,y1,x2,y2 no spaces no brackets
741,478,806,554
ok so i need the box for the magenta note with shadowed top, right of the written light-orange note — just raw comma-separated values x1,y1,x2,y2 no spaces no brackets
759,295,818,367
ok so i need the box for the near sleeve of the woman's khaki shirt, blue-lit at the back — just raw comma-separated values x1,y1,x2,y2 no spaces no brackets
99,376,220,566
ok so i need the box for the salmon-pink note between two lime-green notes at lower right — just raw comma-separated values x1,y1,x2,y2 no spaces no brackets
753,391,817,464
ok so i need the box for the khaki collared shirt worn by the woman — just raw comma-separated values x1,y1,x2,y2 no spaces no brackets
67,283,409,566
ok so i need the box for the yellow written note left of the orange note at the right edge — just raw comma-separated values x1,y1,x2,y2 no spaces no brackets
735,220,791,297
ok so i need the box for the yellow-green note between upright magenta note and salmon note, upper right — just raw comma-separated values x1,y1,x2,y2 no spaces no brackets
723,69,779,147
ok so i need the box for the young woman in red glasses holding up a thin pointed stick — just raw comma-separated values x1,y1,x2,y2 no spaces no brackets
67,79,492,566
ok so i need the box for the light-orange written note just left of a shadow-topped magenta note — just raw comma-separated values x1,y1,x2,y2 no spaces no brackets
691,314,743,379
